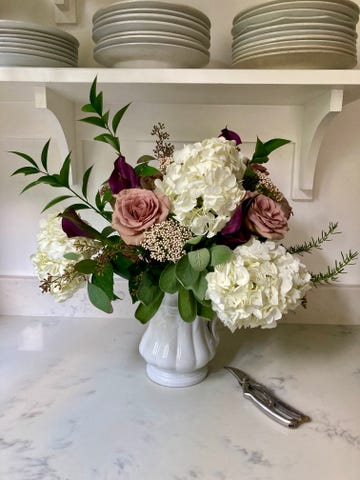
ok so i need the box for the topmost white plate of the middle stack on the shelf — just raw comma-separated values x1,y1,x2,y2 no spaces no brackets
93,0,210,27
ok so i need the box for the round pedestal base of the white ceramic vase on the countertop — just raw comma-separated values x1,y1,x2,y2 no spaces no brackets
146,363,208,387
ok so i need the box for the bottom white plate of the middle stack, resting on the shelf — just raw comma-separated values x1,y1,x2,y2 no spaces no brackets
94,43,209,68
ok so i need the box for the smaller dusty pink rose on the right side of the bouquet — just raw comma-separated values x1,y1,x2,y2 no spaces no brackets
245,195,289,240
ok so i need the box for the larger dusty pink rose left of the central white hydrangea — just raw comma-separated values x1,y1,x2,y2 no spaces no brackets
112,188,170,245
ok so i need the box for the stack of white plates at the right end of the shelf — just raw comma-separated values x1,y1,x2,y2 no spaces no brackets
231,0,359,68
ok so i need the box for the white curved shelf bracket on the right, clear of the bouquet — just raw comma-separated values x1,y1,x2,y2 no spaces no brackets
291,88,344,200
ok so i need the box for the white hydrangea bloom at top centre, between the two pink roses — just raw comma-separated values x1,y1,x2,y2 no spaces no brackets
155,137,246,238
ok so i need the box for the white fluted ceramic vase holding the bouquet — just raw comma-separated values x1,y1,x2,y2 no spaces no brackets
139,294,219,387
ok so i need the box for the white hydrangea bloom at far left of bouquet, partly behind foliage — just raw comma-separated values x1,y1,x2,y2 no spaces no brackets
31,213,91,302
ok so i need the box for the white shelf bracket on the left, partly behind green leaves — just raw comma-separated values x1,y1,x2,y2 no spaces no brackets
34,86,83,185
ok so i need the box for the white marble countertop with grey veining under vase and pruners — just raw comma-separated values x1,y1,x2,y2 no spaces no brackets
0,317,360,480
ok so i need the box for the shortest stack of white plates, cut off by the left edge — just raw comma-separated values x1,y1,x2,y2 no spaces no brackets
0,20,79,67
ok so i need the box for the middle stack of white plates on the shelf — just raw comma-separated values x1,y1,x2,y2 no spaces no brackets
93,0,210,68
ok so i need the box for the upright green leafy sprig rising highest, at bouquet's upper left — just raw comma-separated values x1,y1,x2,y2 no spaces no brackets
80,77,130,155
